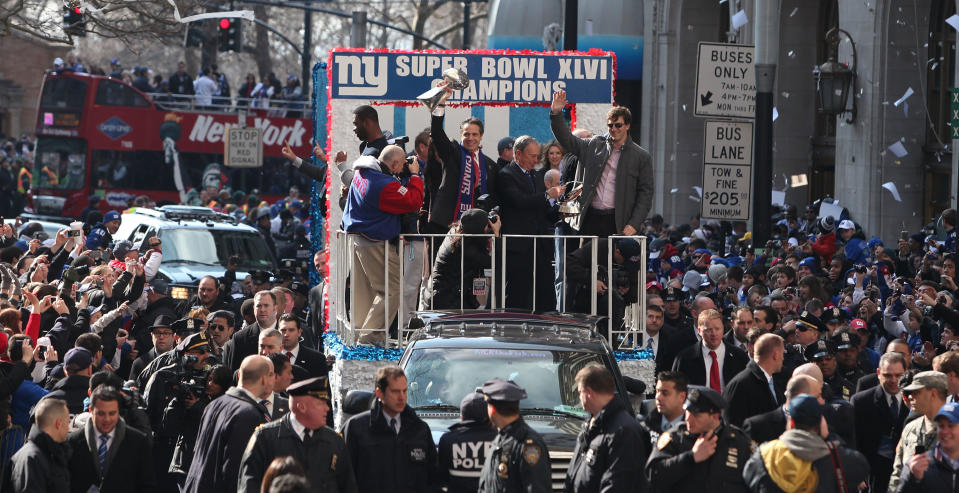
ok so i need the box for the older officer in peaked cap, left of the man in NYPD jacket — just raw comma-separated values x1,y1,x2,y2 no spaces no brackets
239,377,357,493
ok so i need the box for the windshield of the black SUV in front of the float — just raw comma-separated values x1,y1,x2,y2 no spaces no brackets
404,348,605,417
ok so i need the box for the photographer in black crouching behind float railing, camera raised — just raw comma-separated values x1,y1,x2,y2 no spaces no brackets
422,209,502,310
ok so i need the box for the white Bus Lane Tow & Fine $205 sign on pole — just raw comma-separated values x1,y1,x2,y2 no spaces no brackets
702,121,753,221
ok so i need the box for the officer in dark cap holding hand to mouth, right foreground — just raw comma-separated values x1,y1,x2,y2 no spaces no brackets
646,385,751,493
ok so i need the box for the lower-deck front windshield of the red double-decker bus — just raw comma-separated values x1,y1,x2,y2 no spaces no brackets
33,137,86,190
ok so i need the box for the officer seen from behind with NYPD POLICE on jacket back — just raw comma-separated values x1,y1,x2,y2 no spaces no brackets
437,392,496,493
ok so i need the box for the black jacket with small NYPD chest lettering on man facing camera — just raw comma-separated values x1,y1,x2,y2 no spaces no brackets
343,401,437,493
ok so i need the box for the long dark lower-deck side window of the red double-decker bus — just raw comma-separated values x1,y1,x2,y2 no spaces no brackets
91,149,175,190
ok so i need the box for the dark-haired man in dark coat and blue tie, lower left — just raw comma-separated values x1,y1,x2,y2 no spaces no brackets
67,385,156,493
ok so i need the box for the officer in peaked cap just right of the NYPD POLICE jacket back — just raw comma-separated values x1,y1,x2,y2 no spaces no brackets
478,378,552,493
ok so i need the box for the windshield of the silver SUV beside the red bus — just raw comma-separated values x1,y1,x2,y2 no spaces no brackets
160,228,273,271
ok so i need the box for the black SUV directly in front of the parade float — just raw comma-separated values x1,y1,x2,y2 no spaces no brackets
348,311,643,491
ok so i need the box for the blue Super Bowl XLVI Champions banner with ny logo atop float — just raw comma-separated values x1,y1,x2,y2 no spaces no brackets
330,50,615,104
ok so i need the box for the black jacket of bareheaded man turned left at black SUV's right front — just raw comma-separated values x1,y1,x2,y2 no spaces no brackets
566,398,649,493
